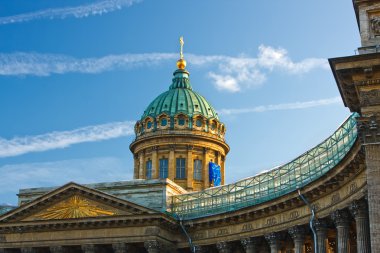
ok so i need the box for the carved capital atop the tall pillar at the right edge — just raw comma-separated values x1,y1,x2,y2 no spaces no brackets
357,115,380,145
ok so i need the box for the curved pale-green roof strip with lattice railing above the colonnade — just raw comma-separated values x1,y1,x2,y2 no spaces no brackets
168,114,357,219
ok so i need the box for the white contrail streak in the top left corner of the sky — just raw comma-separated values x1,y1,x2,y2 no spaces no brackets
0,0,141,25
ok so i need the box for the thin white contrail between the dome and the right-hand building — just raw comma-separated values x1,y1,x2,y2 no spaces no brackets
218,97,342,115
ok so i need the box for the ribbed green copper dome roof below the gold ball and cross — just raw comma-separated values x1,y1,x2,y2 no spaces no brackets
141,69,218,120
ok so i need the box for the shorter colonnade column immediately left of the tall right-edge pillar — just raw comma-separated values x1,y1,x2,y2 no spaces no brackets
349,199,371,253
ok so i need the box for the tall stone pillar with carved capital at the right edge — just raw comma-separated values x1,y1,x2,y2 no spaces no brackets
358,115,380,253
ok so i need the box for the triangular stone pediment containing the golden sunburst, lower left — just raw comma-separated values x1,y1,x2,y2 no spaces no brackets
0,183,157,223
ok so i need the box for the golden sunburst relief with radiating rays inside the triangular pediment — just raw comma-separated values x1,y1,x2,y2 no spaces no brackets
34,196,117,220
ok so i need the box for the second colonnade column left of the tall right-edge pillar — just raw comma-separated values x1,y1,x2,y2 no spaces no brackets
331,210,350,253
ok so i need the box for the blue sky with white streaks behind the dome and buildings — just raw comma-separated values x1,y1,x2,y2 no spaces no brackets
0,0,360,204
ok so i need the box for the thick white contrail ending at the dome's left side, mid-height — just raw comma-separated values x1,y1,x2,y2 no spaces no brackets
0,121,134,158
